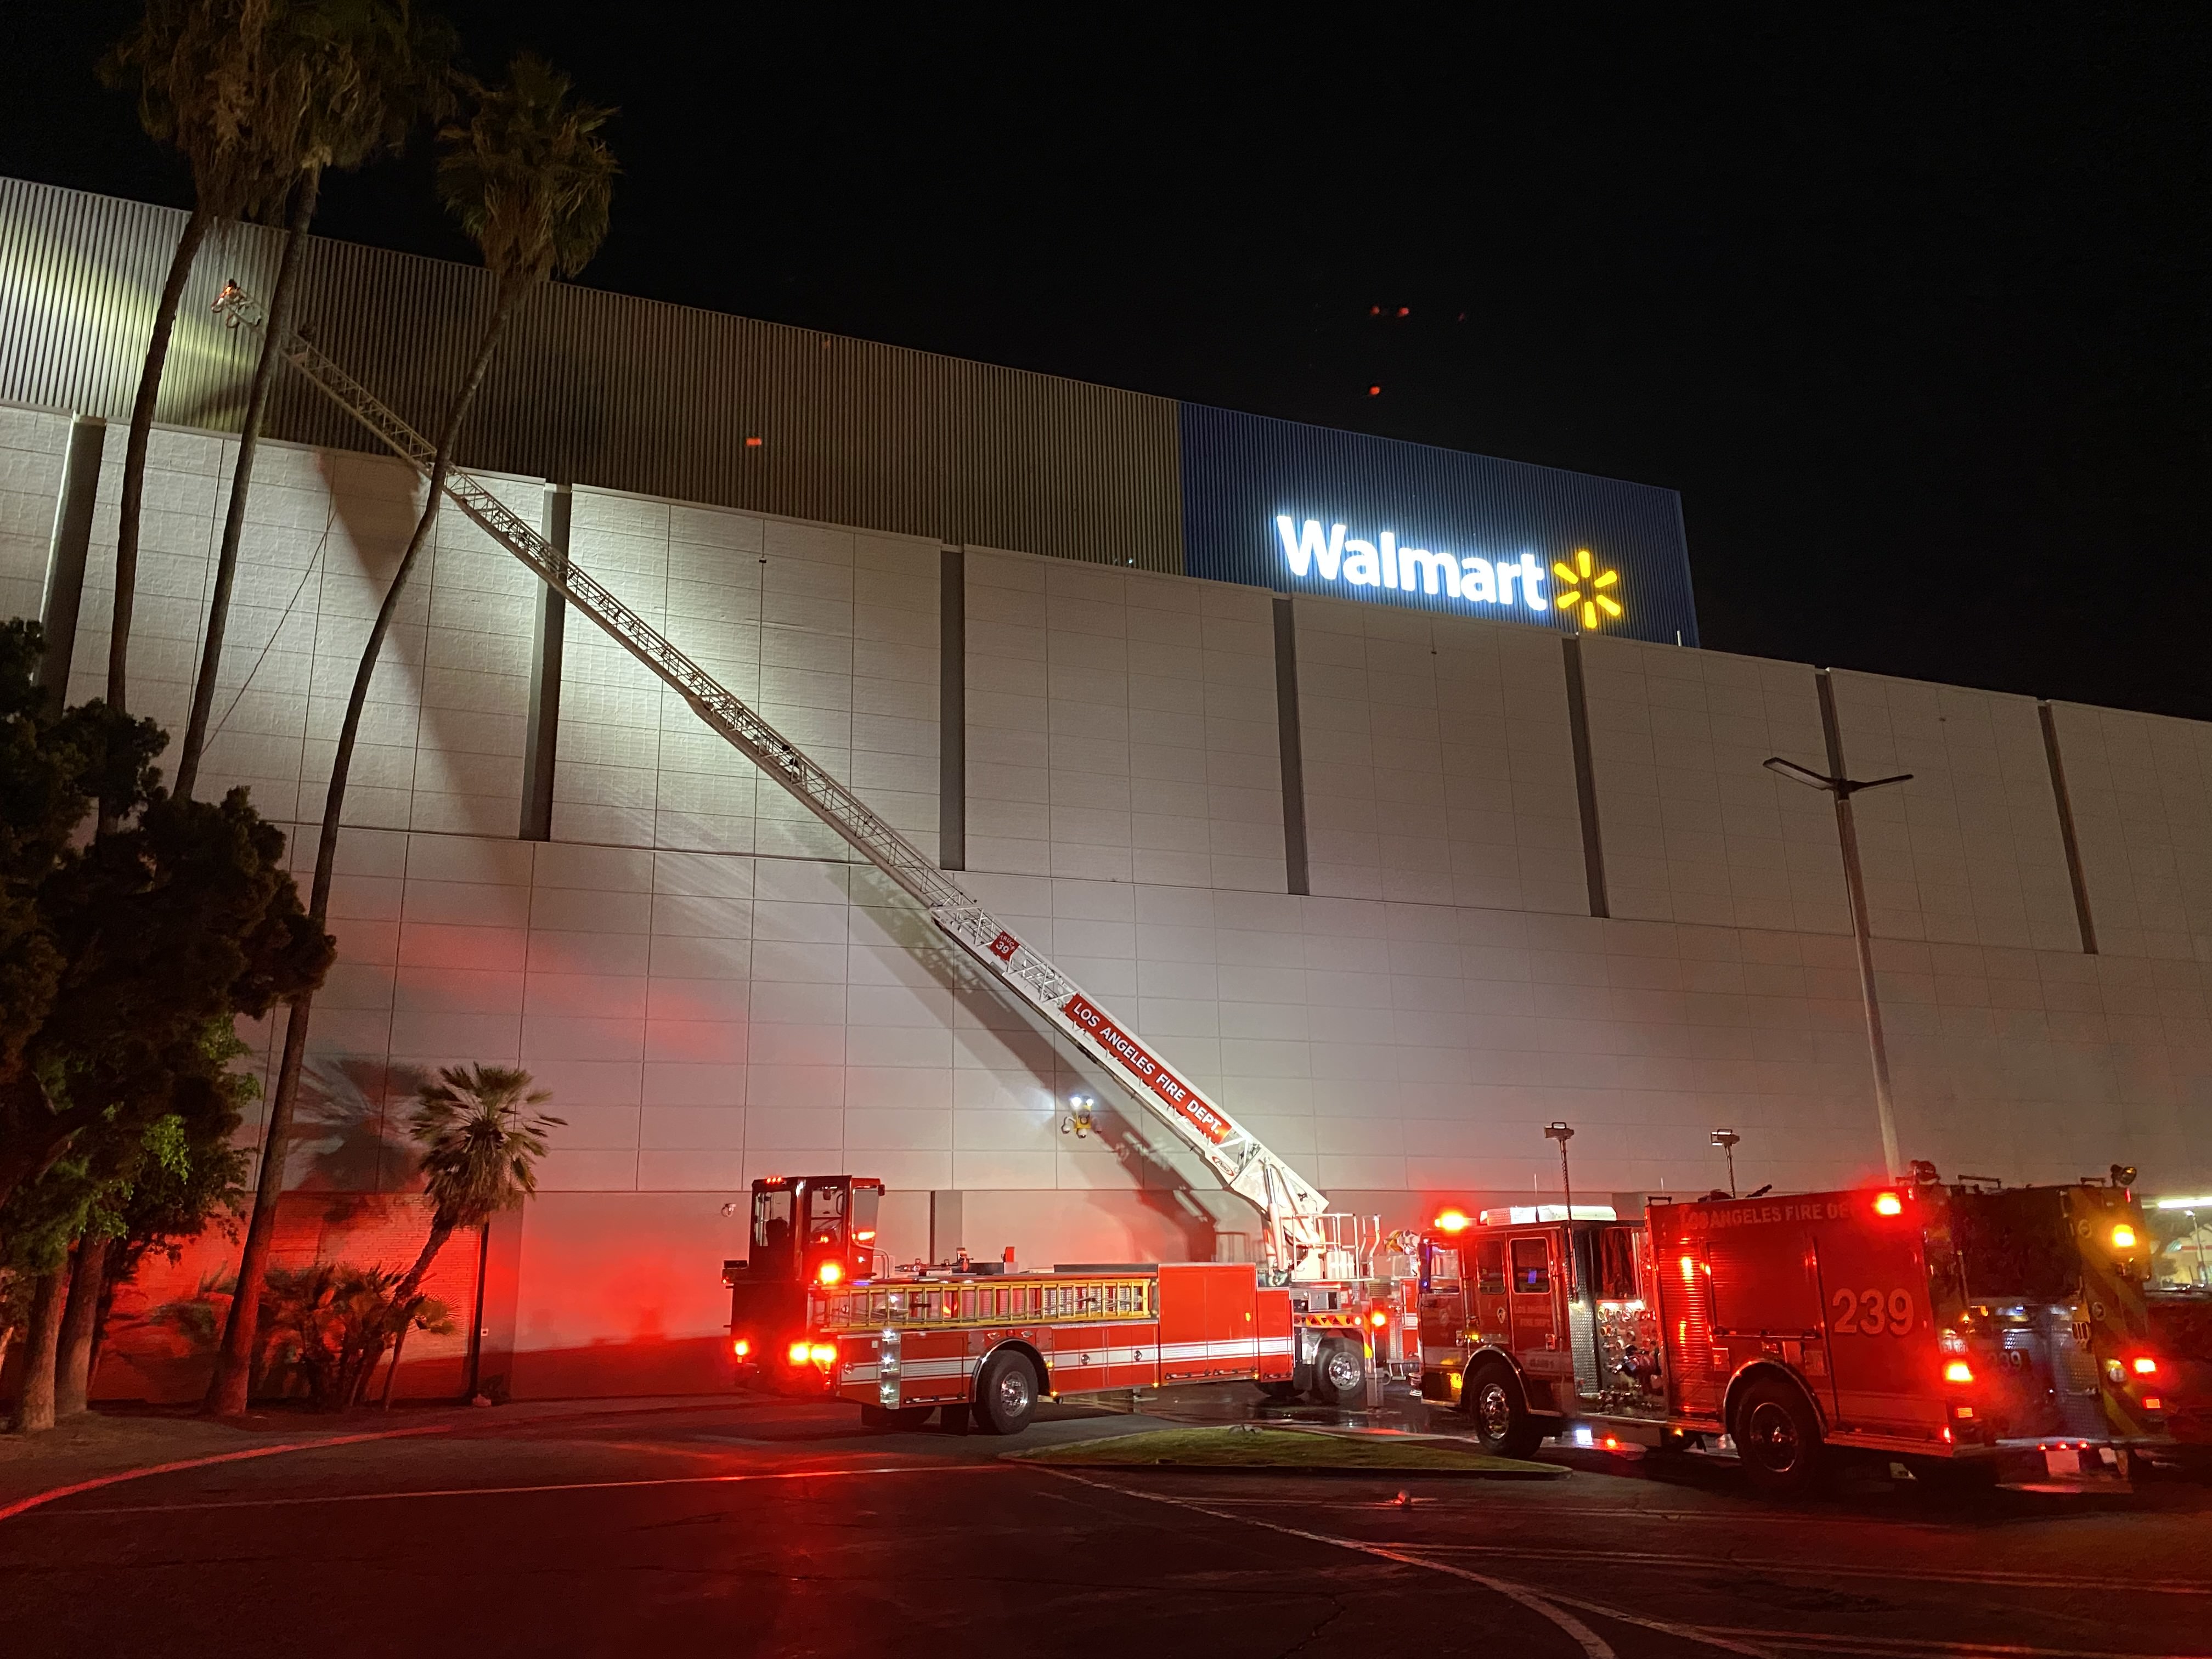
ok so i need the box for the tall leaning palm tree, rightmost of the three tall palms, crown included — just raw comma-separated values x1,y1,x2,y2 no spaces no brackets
208,53,617,1415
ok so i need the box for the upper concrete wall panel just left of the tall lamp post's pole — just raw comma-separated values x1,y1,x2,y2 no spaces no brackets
1584,637,1852,934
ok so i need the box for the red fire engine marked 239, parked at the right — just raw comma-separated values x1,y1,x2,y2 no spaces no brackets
1420,1168,2172,1491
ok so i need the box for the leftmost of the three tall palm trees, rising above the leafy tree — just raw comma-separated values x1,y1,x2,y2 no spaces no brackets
99,0,298,710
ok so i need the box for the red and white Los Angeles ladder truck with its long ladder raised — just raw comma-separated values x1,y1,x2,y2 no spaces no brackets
215,283,1418,1427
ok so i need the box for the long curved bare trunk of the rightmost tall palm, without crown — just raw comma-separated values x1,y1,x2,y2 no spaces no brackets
201,294,520,1415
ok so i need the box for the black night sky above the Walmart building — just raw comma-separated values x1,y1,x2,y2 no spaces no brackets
0,0,2212,719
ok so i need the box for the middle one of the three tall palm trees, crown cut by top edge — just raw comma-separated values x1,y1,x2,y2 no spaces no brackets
177,0,454,801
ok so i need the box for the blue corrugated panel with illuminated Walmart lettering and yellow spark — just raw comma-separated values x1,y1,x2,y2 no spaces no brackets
1181,403,1697,646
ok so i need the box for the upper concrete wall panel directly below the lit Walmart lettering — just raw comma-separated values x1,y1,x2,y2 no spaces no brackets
1296,597,1588,916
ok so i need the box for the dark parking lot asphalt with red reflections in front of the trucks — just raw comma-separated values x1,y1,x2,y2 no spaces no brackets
0,1400,2212,1659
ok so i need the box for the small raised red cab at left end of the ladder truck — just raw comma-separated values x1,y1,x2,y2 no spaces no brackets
721,1175,883,1391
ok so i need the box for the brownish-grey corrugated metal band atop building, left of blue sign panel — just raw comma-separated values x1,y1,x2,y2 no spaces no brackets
0,179,1183,571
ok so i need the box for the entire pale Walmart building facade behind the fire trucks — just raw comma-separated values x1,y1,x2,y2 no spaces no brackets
0,184,2212,1396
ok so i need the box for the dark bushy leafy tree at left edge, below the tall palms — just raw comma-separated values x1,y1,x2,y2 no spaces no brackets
0,619,332,1415
